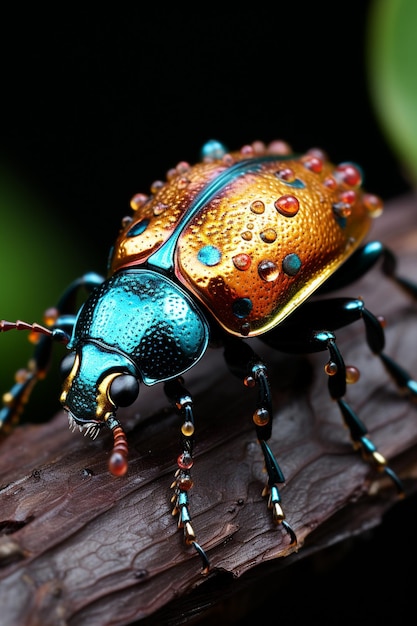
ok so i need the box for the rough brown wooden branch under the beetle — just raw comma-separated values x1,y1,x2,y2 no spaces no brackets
0,197,417,626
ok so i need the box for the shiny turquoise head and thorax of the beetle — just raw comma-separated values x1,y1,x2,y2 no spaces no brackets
61,269,209,460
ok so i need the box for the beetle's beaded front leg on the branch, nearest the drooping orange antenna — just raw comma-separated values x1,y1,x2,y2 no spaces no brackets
164,378,210,574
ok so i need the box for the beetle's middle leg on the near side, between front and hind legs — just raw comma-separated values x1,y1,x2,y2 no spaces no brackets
224,338,297,546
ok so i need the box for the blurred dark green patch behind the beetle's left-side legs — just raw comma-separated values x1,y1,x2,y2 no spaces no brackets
0,158,100,421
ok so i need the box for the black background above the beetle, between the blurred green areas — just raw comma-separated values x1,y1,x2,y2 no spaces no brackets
1,0,407,260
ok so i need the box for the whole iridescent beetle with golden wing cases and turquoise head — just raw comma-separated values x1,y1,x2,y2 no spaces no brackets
0,141,417,572
